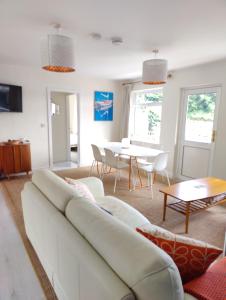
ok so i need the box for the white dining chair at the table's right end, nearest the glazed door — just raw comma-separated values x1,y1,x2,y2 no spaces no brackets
139,152,170,198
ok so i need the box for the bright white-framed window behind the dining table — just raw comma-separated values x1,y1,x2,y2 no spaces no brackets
129,88,163,144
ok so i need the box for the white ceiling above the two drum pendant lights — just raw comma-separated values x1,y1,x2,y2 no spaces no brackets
0,0,226,79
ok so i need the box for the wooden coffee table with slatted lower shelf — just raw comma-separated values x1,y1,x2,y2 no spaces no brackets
160,177,226,233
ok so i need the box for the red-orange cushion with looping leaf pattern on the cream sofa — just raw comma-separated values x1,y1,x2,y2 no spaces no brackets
136,224,222,283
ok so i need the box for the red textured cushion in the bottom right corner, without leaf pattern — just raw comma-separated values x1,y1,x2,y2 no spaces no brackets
184,258,226,300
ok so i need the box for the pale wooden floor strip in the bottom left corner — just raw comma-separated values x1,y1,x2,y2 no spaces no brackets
0,184,46,300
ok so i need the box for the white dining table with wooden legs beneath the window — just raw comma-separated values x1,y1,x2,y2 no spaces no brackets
98,142,163,190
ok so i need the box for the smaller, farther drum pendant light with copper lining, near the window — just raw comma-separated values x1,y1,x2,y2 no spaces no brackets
142,49,167,84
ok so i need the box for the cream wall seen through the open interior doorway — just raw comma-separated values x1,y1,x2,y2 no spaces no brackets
51,92,68,163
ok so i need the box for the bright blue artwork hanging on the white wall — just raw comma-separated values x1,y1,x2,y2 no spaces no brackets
94,91,113,121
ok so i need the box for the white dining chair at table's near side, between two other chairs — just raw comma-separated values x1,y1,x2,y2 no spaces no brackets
104,148,129,193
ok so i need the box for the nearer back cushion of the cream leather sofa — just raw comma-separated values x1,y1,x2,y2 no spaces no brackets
65,198,184,300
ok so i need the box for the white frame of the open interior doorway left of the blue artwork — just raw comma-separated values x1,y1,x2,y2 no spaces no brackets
46,87,80,169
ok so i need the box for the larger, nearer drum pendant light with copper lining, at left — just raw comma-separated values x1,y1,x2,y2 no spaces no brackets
41,24,75,73
